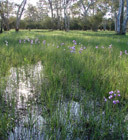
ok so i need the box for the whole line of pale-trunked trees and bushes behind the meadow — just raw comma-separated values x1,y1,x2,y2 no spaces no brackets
0,0,128,34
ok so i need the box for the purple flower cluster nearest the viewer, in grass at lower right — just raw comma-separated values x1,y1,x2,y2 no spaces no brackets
104,90,120,104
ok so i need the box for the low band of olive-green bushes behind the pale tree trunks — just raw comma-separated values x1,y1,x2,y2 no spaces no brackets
9,17,115,31
